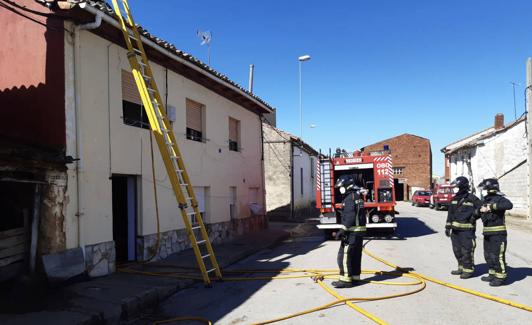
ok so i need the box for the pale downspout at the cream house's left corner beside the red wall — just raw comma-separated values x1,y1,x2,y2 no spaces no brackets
73,12,103,247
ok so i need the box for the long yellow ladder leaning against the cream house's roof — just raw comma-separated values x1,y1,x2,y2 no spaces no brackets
113,0,222,285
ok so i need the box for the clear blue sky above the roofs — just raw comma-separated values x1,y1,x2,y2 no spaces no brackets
130,0,532,175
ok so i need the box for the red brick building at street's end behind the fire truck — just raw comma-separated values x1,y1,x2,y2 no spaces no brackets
362,133,432,201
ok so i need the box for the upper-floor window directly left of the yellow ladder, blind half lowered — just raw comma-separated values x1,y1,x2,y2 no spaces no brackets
122,70,150,129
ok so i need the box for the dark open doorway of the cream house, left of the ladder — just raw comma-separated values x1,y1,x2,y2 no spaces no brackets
112,175,137,262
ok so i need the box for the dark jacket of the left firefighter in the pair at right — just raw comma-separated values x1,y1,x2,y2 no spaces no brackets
445,191,482,231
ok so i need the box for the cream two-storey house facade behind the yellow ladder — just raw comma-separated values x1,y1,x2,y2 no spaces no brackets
57,3,272,276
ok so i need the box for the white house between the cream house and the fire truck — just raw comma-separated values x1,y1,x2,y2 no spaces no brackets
263,123,318,218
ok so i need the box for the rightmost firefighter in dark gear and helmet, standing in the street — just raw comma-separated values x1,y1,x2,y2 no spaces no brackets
479,178,513,287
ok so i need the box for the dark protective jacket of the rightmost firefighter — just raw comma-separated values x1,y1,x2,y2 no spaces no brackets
480,193,514,236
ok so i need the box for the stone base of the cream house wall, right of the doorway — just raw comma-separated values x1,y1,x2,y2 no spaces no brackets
137,216,267,261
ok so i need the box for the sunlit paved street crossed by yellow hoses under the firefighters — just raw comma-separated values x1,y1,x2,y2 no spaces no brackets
139,203,532,324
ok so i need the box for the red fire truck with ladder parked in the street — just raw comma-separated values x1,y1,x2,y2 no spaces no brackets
316,151,397,236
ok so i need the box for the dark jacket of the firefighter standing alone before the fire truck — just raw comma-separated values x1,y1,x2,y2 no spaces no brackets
340,191,366,234
